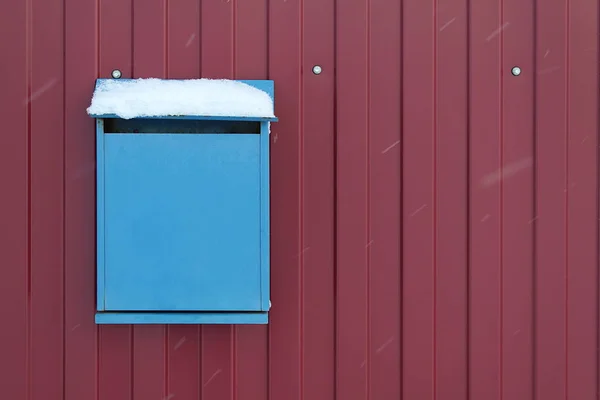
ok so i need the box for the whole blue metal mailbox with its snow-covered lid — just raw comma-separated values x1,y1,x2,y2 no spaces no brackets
87,79,277,324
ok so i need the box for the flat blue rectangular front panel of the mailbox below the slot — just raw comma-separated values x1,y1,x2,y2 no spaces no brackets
104,133,261,311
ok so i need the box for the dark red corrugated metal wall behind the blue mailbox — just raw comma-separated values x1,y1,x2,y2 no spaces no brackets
0,0,599,400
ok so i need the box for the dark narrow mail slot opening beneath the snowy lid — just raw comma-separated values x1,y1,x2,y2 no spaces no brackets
104,118,260,134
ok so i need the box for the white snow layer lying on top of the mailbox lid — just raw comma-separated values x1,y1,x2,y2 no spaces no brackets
87,78,274,119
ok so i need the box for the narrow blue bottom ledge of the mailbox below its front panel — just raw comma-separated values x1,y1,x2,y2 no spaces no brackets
96,312,269,324
